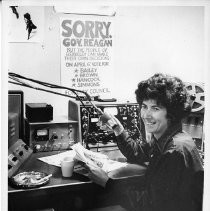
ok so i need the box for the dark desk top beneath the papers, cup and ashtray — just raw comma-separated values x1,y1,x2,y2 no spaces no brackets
8,150,146,210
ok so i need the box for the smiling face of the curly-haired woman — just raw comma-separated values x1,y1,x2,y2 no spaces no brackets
141,99,168,139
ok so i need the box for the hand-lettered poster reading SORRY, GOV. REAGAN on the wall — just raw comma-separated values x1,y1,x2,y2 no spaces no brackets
60,15,114,98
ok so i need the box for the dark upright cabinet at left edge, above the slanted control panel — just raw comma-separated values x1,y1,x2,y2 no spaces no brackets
8,90,24,145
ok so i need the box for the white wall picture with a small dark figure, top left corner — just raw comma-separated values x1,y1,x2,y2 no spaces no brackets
7,6,44,42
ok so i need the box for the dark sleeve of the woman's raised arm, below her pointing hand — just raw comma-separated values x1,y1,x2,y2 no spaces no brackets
117,131,150,164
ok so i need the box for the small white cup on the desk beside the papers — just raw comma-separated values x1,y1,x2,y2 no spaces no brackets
61,157,74,177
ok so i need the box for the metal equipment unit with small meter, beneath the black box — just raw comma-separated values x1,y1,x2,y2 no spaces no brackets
25,118,78,152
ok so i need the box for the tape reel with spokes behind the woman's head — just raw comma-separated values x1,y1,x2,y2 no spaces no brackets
185,83,205,112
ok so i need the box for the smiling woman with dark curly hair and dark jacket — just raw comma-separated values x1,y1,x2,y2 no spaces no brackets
84,74,203,211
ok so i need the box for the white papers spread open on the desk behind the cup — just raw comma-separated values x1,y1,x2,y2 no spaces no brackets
39,143,127,173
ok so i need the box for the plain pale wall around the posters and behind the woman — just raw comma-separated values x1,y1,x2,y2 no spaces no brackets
8,6,204,116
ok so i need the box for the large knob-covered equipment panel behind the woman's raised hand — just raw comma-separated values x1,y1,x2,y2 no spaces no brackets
68,100,139,148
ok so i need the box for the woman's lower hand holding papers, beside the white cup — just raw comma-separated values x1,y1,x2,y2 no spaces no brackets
85,163,109,187
